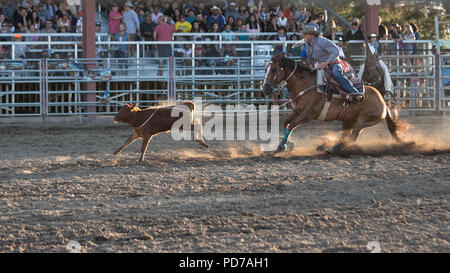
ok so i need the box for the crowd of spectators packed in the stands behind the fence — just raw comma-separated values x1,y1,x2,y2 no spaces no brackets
0,0,420,61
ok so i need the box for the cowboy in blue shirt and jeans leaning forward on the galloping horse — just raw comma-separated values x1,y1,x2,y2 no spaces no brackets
303,27,363,102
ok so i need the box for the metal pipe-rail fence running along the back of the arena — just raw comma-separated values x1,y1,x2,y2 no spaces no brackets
0,40,442,117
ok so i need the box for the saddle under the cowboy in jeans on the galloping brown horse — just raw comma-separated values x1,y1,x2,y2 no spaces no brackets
324,68,365,106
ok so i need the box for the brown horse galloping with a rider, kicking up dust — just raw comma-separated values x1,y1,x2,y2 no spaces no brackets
263,54,404,153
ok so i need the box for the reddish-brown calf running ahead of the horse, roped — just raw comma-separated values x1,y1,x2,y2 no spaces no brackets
114,102,208,161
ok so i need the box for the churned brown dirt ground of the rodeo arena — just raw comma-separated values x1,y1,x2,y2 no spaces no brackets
0,113,450,252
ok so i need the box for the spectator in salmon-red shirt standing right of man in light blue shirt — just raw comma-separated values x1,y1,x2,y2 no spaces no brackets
153,16,175,76
